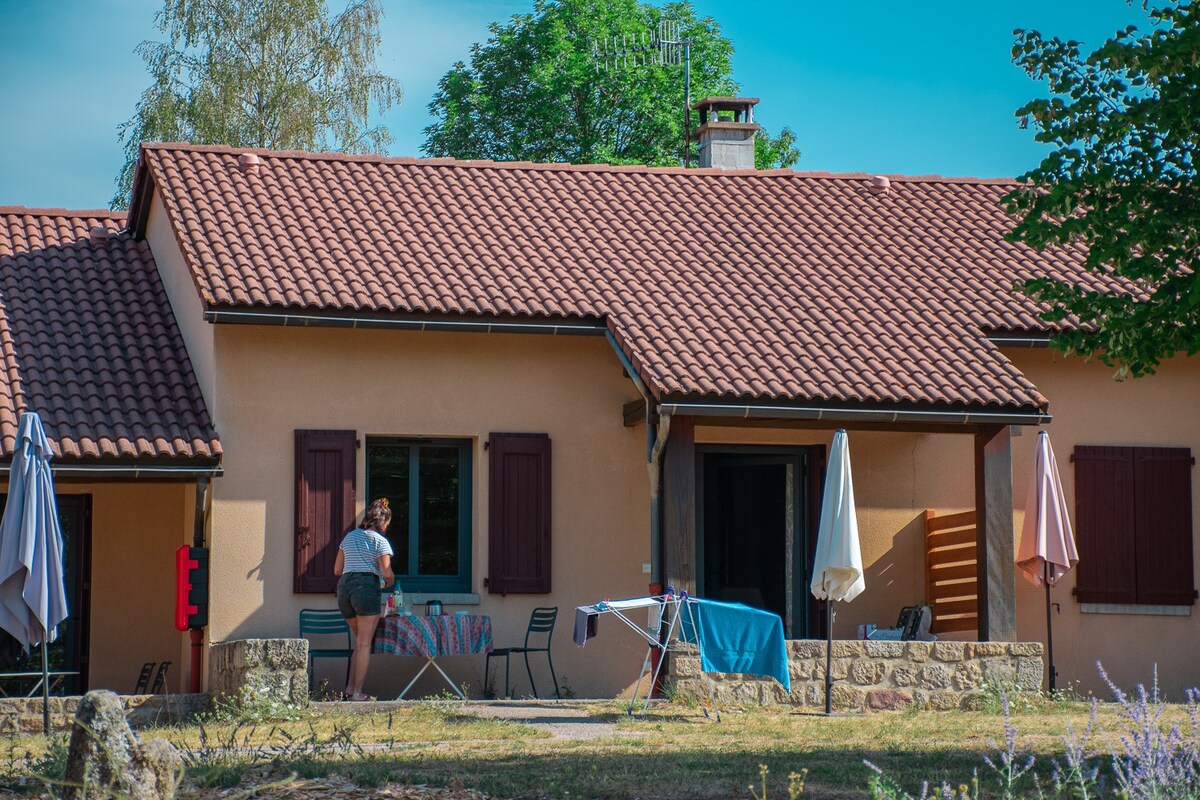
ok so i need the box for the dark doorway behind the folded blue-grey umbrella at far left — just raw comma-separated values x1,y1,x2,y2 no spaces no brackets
0,494,91,696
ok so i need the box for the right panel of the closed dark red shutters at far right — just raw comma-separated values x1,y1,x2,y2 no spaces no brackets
1128,447,1196,606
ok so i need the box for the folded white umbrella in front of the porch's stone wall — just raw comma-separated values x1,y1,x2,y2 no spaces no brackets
809,429,866,714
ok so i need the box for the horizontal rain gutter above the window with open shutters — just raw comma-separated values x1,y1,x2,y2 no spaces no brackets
204,308,607,336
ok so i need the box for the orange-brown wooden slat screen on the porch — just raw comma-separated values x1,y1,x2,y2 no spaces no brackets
925,510,979,633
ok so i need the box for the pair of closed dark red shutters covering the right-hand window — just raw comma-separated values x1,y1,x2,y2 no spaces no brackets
1072,446,1196,606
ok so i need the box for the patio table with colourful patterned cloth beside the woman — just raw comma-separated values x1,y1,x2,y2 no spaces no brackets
371,614,492,700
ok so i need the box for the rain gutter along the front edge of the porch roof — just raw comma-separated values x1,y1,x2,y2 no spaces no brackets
659,402,1051,425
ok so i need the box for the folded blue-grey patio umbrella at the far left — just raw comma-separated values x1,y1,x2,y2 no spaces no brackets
0,411,67,735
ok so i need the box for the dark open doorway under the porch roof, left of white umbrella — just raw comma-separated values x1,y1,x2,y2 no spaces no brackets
697,447,820,638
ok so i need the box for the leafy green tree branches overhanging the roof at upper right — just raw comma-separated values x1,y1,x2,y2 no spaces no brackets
1007,2,1200,377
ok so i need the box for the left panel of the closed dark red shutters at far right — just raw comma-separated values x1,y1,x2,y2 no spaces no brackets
1073,446,1138,603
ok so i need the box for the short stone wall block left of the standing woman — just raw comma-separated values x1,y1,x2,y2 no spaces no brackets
209,639,308,705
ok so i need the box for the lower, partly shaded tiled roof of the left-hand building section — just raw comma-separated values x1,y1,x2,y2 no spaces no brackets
0,206,221,461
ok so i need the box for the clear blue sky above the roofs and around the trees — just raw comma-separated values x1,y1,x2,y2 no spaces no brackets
0,0,1145,209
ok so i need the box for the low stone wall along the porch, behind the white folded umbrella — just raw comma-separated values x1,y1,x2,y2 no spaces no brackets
670,639,1043,711
